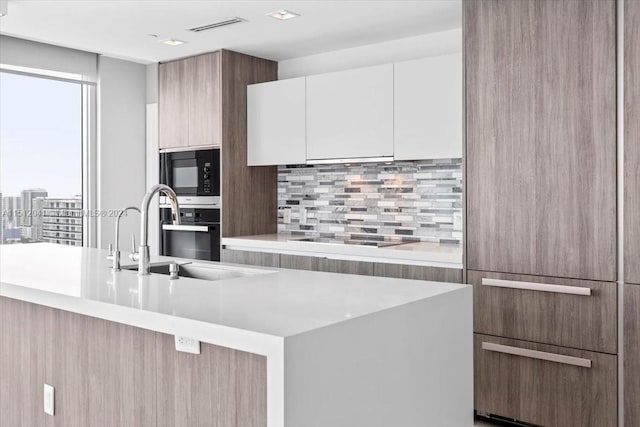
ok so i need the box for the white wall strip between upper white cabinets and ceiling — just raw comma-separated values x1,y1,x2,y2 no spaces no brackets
278,29,462,79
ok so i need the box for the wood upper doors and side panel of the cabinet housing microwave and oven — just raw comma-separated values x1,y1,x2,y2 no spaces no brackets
158,50,278,237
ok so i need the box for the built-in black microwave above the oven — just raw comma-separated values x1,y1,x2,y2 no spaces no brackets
160,148,220,196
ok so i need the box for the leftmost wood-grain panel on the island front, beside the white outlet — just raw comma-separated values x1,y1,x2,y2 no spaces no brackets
0,297,47,427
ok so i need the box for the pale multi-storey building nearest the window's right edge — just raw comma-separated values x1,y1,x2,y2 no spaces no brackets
36,196,82,246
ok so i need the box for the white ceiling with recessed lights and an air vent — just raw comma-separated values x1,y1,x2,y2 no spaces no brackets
0,0,462,63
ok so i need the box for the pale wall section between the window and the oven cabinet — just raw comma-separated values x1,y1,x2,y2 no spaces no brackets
97,56,147,251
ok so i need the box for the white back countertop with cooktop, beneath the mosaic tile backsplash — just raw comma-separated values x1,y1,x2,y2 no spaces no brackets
222,234,462,269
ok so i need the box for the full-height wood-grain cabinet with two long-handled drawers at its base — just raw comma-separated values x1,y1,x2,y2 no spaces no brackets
464,0,618,427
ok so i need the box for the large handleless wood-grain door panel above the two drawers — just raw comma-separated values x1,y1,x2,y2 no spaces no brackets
464,0,616,281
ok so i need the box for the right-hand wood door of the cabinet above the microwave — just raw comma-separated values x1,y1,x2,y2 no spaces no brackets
188,52,222,147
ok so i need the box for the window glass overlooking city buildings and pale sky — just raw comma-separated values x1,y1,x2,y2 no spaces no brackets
0,71,85,246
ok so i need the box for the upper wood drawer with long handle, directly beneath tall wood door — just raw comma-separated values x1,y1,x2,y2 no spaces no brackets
468,271,617,354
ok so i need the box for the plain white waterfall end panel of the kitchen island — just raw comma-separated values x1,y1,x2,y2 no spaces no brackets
285,286,473,427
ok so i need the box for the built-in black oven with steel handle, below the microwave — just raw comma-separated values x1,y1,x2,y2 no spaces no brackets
160,207,221,261
